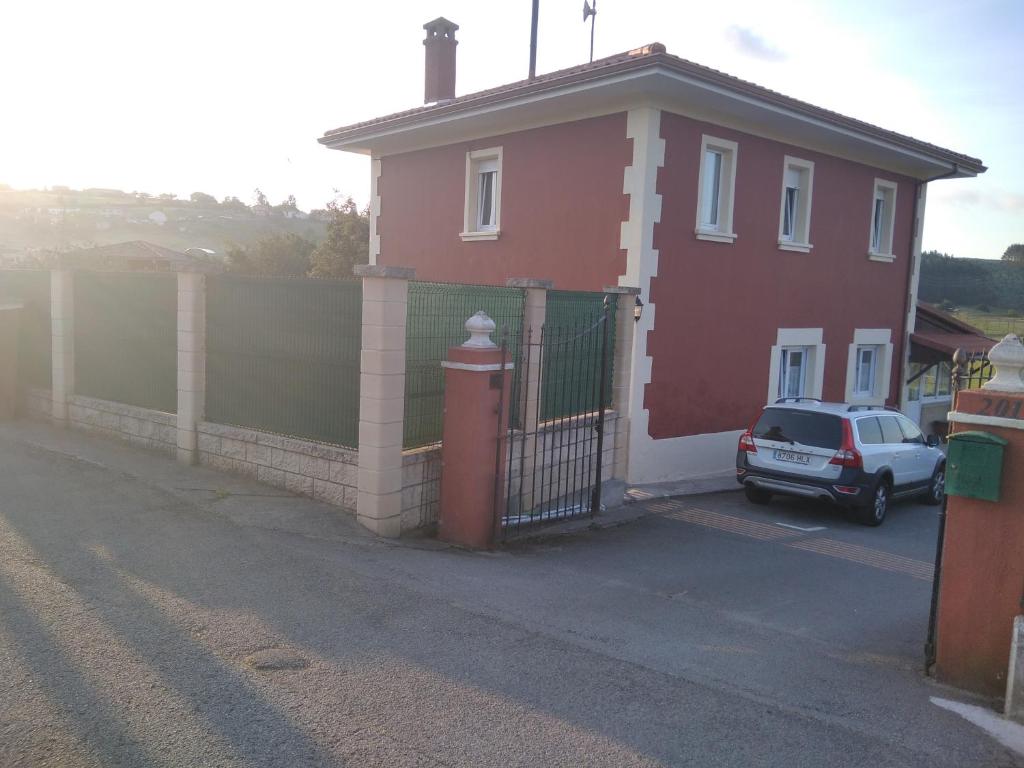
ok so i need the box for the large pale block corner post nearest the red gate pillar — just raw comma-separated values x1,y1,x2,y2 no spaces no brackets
354,264,416,538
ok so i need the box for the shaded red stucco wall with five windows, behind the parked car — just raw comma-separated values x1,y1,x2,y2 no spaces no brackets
644,113,914,438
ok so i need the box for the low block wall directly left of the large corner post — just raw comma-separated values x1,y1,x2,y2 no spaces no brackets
197,422,358,512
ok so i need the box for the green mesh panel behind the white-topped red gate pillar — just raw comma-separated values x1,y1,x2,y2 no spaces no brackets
403,283,524,449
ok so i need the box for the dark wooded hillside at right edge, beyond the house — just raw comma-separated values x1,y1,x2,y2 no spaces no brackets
919,251,1024,312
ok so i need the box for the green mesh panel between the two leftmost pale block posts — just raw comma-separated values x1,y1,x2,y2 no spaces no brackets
74,271,178,413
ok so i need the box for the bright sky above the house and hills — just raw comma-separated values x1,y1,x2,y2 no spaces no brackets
0,0,1024,258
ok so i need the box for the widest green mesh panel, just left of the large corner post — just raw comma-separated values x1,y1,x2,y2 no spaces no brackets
206,275,362,447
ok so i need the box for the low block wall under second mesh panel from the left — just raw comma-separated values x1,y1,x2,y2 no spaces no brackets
68,394,178,456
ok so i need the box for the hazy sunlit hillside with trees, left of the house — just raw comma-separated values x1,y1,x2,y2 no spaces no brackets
0,186,326,259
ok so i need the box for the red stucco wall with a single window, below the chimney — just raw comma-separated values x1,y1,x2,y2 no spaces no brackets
377,114,633,291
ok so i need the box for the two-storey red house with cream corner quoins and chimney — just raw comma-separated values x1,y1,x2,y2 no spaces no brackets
319,18,985,482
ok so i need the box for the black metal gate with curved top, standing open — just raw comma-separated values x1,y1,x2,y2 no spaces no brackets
496,296,614,536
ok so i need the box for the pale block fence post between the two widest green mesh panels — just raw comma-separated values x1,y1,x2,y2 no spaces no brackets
177,272,206,464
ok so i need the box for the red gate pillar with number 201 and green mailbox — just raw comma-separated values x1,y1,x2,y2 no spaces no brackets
935,337,1024,696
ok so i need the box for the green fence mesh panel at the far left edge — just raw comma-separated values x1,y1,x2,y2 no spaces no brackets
0,269,52,389
